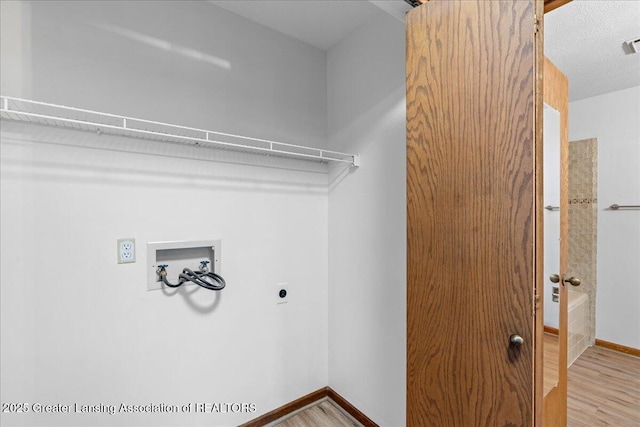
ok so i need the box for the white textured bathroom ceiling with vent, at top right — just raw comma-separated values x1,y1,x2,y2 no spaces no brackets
544,0,640,101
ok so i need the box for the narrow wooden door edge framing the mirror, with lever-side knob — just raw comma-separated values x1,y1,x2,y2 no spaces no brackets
543,58,569,427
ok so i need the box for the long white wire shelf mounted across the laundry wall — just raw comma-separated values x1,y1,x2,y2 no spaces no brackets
0,95,360,167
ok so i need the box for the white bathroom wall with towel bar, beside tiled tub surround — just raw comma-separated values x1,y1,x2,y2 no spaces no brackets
569,87,640,348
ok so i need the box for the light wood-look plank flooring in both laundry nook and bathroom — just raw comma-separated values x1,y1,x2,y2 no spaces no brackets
277,347,640,427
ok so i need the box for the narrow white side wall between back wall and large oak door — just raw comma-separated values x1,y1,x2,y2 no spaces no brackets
328,13,406,426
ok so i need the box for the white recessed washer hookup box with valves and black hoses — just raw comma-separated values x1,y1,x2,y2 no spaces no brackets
147,239,222,291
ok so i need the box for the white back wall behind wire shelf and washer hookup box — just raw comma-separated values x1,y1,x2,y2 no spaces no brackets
0,1,328,426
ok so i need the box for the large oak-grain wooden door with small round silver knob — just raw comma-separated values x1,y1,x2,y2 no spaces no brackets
406,0,542,427
